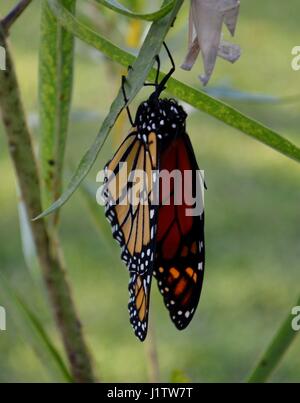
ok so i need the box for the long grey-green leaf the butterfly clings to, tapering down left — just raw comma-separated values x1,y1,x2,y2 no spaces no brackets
36,0,183,219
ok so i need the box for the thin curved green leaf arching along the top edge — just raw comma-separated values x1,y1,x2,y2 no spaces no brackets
95,0,175,21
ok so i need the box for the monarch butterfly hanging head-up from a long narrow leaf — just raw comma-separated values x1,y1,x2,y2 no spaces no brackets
104,44,205,341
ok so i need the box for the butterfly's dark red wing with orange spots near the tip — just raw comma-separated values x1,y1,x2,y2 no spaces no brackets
154,134,205,330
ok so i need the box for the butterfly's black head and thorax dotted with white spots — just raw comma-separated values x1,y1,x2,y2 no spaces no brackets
136,96,187,138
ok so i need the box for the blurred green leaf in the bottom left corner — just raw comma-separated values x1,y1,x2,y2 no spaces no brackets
0,274,73,382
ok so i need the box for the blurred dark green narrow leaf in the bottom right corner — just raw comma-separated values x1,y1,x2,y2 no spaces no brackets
248,298,300,383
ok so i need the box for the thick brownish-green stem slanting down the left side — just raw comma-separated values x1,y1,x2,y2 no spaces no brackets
0,26,94,383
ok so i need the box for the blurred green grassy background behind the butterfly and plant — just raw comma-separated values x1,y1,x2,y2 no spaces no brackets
0,0,300,382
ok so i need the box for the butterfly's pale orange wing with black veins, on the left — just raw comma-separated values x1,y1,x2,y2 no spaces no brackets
104,133,158,341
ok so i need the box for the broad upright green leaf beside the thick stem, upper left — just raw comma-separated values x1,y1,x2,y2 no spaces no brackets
39,0,76,219
